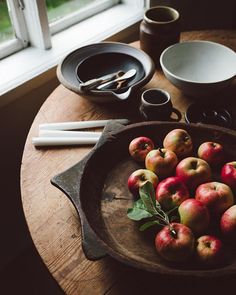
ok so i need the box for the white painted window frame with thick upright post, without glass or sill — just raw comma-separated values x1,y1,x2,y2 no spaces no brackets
0,0,123,59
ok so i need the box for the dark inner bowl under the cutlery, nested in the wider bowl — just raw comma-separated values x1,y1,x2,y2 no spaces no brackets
76,52,145,92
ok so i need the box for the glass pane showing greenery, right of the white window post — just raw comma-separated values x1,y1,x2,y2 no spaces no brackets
46,0,96,23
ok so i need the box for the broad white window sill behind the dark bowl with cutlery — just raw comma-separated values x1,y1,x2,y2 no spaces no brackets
0,3,143,107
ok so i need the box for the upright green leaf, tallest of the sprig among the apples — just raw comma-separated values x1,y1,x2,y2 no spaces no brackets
139,181,156,215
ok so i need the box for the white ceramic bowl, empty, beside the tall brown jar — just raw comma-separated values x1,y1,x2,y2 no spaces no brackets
160,41,236,97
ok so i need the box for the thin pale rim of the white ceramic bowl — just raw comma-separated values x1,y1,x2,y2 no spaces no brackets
160,40,236,85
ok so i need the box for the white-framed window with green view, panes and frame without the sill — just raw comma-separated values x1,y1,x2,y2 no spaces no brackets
0,0,124,59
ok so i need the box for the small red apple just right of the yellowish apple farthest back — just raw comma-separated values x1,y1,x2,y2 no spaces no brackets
198,141,225,166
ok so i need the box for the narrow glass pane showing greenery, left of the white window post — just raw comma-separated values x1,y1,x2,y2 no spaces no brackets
0,0,15,43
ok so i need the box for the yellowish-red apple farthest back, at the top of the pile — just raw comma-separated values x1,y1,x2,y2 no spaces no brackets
163,129,193,158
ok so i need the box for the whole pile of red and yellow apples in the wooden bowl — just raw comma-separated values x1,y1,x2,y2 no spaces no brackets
128,129,236,266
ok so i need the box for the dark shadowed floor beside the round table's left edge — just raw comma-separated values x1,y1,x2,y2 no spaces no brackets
0,81,64,295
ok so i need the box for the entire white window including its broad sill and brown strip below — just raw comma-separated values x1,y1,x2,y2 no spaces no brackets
0,0,145,100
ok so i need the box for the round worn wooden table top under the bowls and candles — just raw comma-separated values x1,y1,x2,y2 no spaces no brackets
21,31,236,295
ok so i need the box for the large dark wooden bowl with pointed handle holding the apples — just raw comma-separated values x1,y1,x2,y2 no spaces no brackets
52,121,236,277
